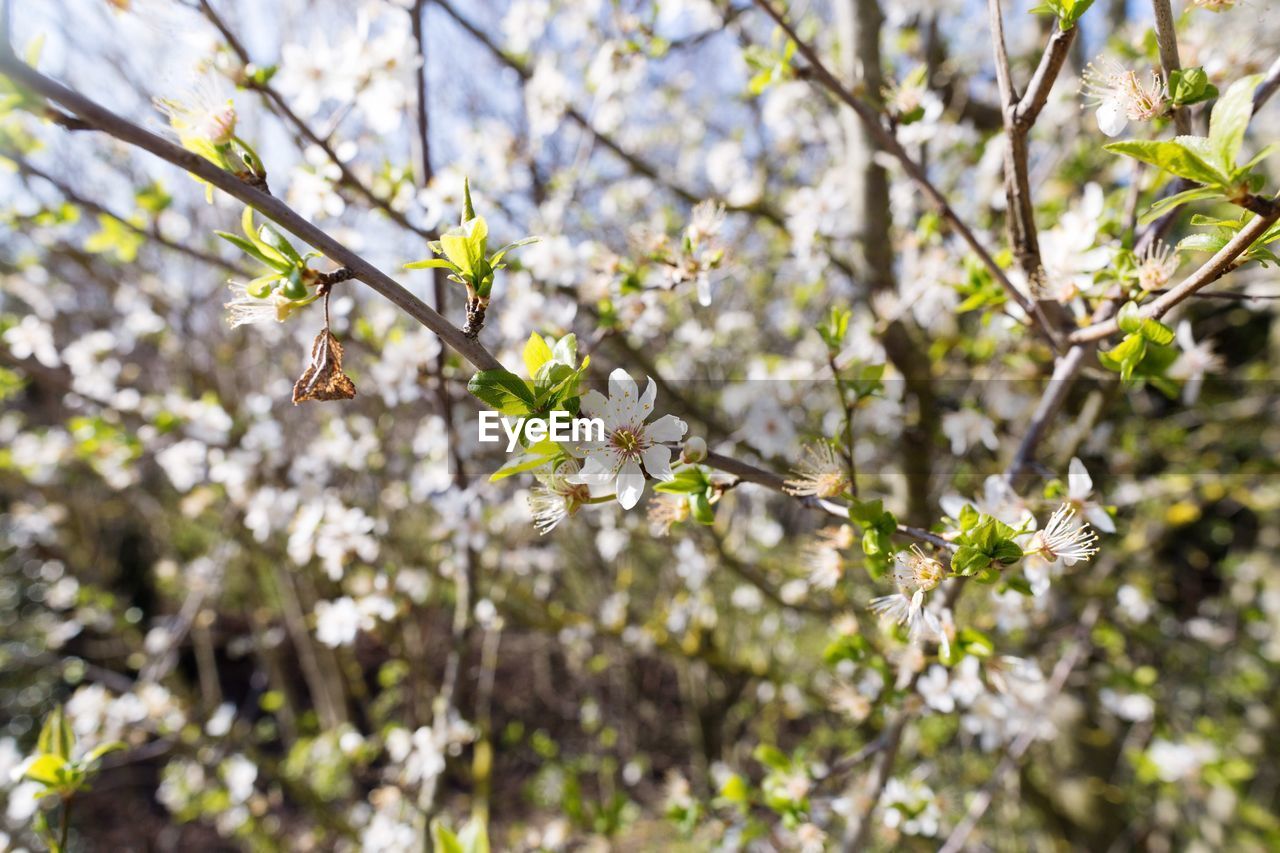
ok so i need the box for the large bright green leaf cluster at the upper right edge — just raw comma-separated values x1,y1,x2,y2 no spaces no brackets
1106,74,1280,222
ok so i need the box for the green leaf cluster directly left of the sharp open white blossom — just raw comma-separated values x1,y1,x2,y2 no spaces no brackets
467,332,591,480
